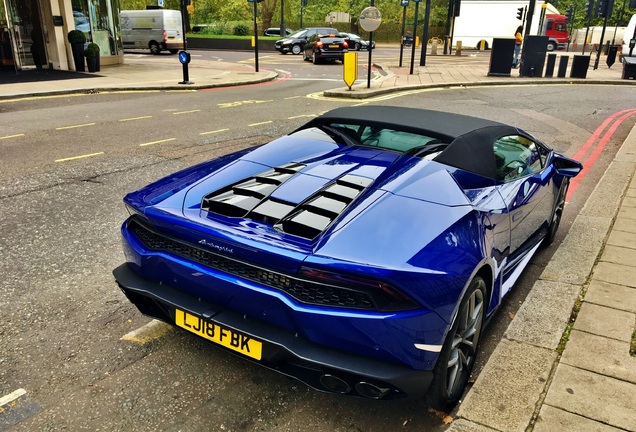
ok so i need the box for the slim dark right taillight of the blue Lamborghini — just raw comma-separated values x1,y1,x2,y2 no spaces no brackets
298,267,418,312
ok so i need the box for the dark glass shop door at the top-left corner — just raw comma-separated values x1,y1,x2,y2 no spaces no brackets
6,0,48,70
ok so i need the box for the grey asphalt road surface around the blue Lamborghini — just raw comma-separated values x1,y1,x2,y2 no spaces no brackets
0,54,636,431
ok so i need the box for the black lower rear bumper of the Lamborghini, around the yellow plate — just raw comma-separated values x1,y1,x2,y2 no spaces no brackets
113,264,433,399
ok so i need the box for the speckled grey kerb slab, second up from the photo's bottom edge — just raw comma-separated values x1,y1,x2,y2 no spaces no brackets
504,280,581,349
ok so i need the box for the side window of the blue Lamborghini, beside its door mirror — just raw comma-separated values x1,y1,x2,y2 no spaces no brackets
493,135,548,182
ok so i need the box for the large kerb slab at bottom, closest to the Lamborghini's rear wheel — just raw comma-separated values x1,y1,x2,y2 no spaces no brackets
457,339,557,432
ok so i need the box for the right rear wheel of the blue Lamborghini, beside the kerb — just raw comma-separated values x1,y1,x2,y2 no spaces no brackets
426,276,487,411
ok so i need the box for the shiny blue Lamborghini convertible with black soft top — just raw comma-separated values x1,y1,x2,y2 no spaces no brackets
113,106,581,409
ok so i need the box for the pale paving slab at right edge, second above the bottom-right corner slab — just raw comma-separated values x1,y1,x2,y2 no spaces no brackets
574,303,636,342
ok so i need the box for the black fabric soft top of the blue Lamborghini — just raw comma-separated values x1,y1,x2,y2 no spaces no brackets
302,105,520,179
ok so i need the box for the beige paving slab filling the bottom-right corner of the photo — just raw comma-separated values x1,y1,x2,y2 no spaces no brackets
545,364,636,432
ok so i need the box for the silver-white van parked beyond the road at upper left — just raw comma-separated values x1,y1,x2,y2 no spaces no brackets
119,9,183,54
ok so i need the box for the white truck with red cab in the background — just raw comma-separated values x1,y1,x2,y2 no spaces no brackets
453,0,567,51
